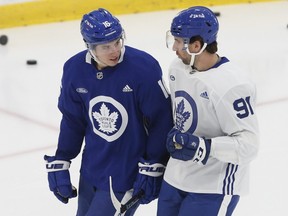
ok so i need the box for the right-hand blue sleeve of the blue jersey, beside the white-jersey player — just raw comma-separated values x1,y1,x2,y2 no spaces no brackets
138,60,173,163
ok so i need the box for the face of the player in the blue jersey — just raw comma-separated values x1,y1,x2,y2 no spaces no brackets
92,38,123,67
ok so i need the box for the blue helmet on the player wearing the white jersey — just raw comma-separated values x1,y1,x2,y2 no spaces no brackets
170,6,219,44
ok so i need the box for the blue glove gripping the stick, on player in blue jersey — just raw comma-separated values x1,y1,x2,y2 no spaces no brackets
133,159,165,204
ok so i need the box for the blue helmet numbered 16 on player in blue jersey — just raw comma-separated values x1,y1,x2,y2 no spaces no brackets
81,8,124,45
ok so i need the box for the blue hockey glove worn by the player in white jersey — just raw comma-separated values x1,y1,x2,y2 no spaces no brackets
166,128,211,165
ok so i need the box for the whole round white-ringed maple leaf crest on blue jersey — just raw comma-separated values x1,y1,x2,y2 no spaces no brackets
88,96,128,142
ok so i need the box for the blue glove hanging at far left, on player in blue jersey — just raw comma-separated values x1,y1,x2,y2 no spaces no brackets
44,155,77,204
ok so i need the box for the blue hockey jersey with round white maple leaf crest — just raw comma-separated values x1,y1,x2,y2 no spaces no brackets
56,46,173,192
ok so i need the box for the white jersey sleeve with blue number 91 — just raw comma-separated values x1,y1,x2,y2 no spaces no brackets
211,85,259,164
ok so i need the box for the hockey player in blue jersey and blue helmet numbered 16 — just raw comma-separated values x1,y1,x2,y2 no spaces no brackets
44,8,173,216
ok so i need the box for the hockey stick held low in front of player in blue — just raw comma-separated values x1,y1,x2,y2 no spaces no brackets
109,176,144,216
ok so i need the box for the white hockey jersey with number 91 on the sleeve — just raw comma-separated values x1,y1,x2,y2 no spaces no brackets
164,57,259,195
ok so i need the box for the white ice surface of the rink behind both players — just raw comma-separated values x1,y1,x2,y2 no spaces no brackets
0,1,288,216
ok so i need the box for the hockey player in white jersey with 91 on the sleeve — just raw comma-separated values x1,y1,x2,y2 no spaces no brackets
157,6,259,216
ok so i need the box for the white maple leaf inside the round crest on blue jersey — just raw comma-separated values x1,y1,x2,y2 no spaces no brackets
93,103,118,134
